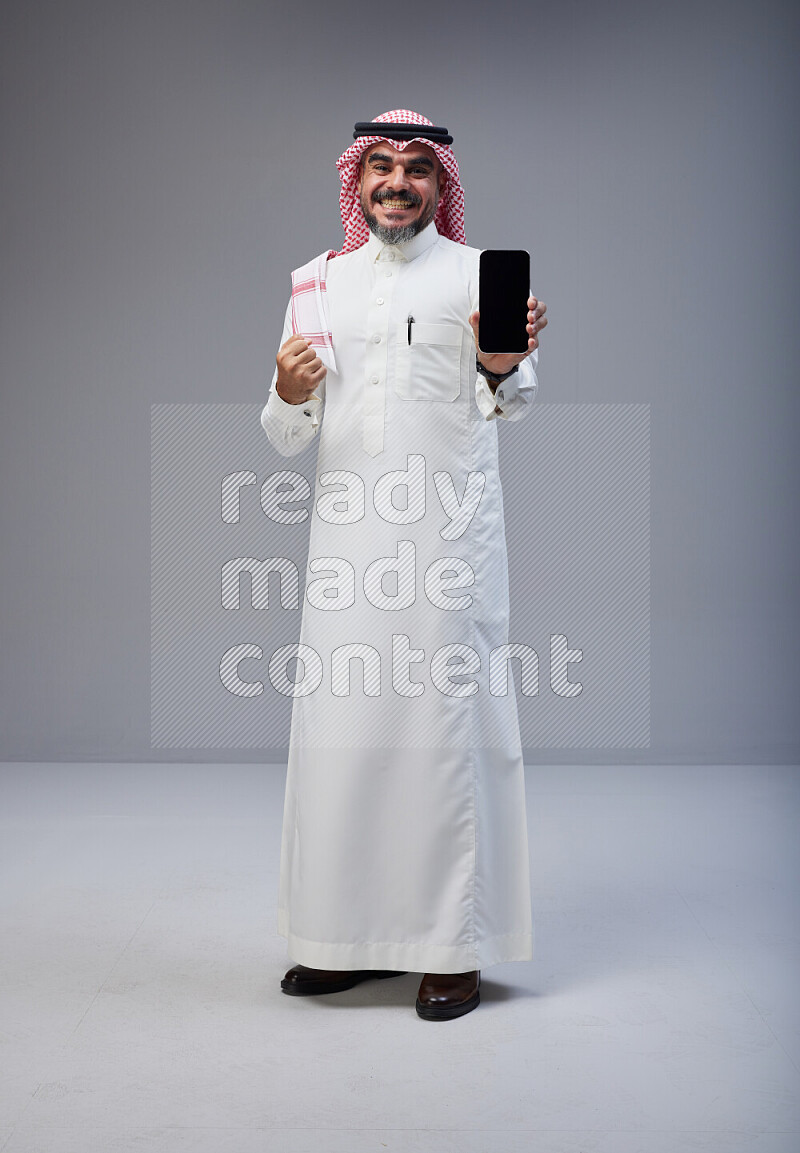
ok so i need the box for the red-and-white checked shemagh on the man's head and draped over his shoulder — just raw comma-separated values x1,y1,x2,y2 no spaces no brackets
292,108,467,372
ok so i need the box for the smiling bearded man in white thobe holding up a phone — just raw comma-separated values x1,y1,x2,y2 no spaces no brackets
262,110,546,1020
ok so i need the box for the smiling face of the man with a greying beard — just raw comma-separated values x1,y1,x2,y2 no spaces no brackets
359,141,447,244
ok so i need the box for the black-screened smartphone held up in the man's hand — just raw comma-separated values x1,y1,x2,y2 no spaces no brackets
477,248,530,353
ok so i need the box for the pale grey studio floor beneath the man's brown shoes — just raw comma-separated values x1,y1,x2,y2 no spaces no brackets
0,764,800,1153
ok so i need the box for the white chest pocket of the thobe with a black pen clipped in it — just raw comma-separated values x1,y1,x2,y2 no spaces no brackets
394,322,463,400
